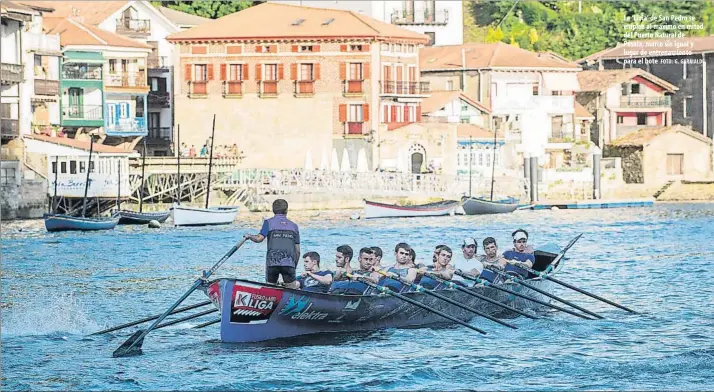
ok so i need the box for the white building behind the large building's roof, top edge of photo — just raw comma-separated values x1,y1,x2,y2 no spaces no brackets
269,0,464,45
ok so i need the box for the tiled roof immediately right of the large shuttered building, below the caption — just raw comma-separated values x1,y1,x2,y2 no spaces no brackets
419,42,580,71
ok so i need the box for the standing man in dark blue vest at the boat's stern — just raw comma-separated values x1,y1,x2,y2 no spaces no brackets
243,199,300,289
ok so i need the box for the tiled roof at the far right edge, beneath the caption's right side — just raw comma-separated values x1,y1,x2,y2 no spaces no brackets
578,35,714,63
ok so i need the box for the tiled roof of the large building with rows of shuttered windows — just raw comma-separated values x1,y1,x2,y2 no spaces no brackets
168,3,428,43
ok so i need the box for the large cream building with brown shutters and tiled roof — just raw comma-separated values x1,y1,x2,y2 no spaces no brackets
168,3,429,169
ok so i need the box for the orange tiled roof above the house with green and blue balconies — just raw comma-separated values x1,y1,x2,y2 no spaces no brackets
42,17,151,49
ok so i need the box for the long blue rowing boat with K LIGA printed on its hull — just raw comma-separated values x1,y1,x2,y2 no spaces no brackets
202,245,564,343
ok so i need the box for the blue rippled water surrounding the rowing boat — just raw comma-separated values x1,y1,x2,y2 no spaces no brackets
0,204,714,390
